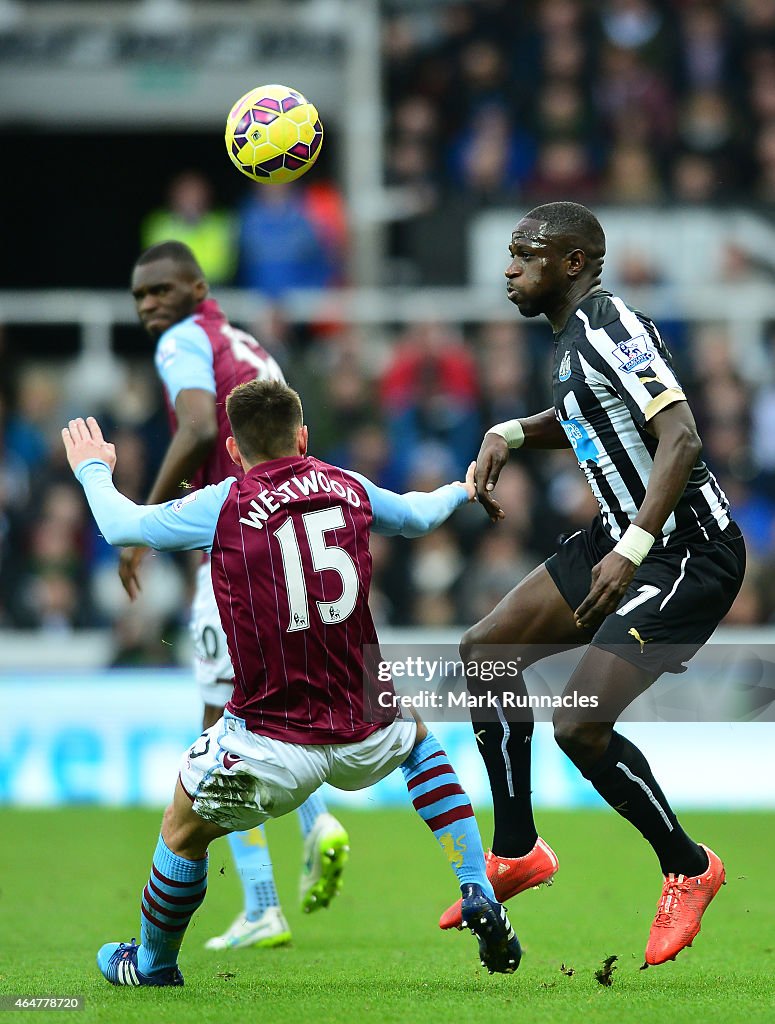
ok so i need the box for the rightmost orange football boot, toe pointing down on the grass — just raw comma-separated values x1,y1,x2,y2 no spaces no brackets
644,843,725,967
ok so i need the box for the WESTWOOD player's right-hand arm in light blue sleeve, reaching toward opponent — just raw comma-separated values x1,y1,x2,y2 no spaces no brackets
351,462,476,538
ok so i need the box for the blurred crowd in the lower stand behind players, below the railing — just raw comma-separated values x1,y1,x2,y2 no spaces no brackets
0,299,775,664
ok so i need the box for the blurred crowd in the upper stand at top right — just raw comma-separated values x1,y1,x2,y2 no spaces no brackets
384,0,775,284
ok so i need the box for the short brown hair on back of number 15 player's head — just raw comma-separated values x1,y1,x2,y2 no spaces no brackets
226,381,304,461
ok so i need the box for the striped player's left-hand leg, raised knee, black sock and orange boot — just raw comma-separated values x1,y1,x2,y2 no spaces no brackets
439,565,577,929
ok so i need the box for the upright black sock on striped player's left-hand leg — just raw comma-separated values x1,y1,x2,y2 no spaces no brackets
472,684,539,857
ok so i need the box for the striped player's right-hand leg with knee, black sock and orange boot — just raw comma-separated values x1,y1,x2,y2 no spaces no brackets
554,647,725,965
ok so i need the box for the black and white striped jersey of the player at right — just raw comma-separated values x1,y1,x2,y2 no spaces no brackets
552,292,730,543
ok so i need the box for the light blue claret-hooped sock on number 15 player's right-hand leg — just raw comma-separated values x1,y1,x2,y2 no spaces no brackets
401,732,496,899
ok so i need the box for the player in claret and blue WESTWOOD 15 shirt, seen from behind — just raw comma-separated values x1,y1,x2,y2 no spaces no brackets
62,381,521,985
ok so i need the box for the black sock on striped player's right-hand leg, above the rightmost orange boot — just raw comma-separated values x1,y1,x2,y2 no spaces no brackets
584,732,707,876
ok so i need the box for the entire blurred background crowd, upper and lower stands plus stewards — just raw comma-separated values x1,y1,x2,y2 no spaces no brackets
0,0,775,665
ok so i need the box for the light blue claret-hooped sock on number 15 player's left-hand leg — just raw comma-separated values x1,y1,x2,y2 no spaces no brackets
137,836,207,974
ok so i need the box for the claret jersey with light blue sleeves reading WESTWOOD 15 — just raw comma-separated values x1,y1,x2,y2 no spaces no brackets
77,456,468,743
